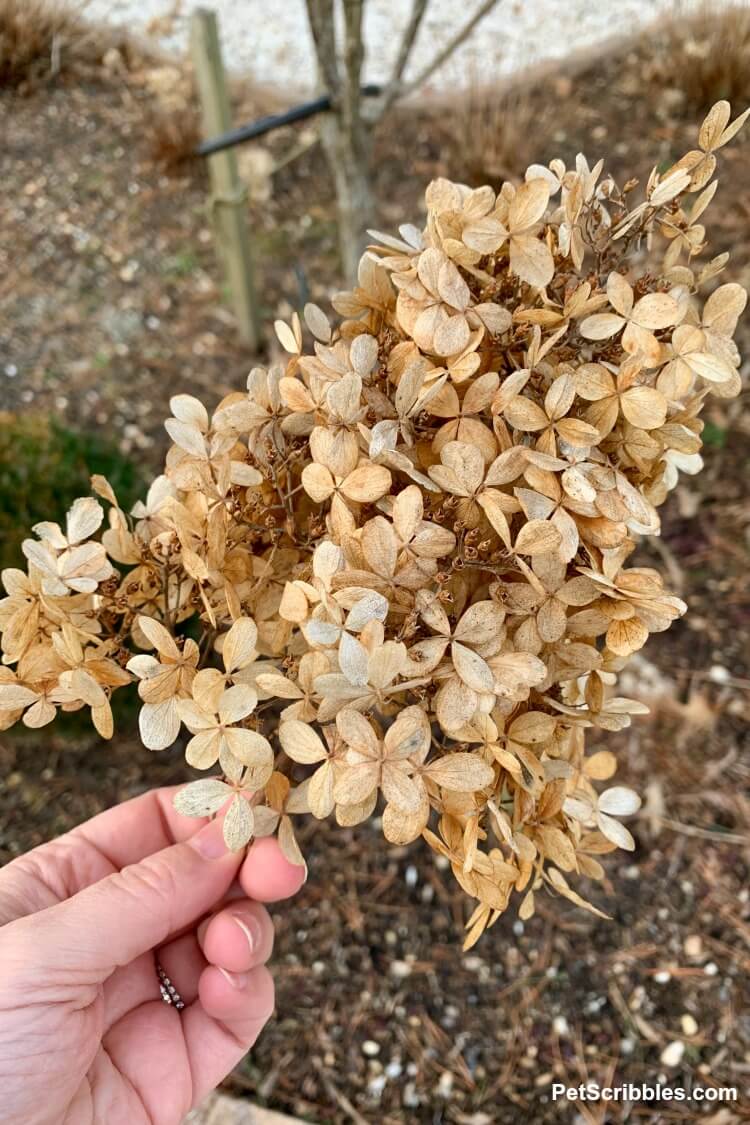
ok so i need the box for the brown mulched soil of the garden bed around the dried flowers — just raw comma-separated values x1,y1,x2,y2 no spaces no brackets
0,21,750,1125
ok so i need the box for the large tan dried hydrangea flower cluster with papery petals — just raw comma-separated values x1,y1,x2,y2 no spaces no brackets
0,102,747,945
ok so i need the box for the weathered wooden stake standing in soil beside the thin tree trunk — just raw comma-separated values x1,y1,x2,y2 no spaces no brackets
190,8,261,349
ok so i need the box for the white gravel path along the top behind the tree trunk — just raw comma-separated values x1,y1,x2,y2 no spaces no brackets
87,0,720,99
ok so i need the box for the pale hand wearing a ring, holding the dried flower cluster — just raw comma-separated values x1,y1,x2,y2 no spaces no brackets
0,790,305,1125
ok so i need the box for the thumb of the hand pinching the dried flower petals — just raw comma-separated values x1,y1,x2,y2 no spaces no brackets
3,820,242,983
